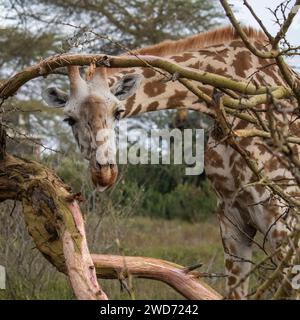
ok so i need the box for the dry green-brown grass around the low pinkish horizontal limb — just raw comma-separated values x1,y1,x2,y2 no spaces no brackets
92,217,224,300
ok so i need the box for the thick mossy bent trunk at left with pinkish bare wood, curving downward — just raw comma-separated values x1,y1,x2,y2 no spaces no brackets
0,125,107,300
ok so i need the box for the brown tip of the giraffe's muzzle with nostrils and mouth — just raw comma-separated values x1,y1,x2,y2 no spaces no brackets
90,158,118,192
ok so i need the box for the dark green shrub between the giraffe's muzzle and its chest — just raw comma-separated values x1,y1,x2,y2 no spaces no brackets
126,165,217,221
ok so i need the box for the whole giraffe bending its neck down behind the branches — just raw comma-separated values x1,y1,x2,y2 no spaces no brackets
43,26,300,299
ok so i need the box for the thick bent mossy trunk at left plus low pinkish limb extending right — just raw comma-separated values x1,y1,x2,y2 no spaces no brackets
0,127,222,300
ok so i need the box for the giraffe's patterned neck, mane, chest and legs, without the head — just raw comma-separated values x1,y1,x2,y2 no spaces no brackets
42,28,300,299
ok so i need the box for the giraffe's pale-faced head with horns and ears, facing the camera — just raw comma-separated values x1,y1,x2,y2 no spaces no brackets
42,66,140,191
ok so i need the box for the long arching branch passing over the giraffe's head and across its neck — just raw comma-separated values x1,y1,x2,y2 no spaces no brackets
0,54,289,99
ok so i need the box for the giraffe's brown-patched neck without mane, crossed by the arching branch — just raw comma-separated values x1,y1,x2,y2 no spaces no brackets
110,39,284,122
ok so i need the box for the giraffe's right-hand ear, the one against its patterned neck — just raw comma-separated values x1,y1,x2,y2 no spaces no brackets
110,74,142,100
